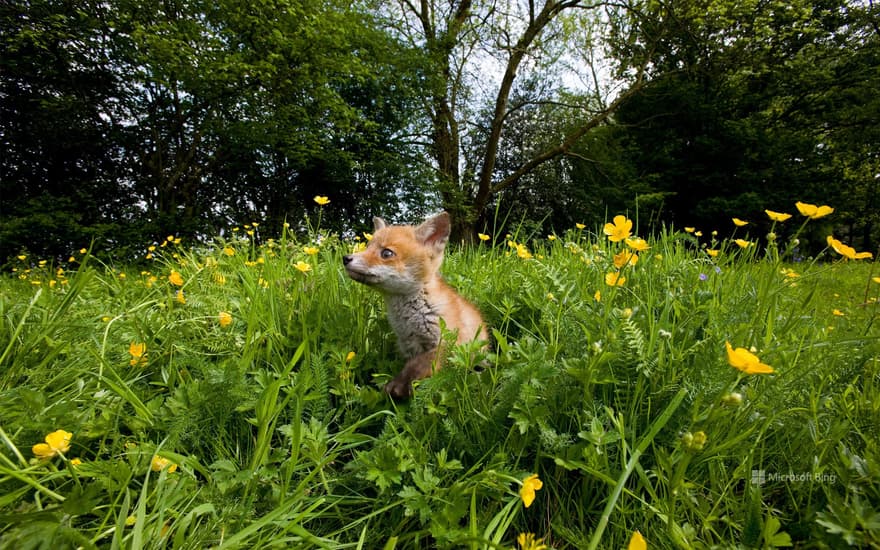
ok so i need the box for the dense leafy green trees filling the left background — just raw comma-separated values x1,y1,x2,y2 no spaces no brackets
0,0,427,258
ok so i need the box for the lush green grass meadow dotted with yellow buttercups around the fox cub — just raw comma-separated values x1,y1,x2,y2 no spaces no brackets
0,202,880,550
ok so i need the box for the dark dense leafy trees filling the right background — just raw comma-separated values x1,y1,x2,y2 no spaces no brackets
618,0,880,247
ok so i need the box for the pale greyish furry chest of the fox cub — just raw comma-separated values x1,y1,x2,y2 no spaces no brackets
386,292,440,358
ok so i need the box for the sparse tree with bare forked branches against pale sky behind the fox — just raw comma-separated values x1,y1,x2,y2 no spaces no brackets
368,0,651,242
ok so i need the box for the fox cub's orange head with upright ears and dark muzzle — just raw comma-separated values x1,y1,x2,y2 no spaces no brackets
342,212,450,294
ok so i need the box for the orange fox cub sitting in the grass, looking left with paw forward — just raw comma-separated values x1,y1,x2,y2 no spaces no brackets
342,212,487,398
